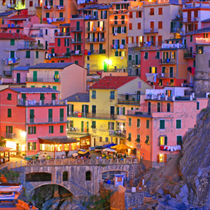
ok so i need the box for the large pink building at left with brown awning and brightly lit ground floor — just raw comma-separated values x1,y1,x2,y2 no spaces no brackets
0,88,76,157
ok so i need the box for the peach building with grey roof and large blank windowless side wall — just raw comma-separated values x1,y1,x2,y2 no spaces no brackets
26,63,87,99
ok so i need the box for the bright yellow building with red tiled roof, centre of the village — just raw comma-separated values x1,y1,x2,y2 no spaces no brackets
65,76,151,148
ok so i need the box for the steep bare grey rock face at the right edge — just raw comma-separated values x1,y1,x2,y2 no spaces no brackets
179,106,210,209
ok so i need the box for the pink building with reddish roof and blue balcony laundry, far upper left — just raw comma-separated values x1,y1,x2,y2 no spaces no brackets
1,14,40,34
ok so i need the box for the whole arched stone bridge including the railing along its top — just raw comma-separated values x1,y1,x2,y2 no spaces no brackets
20,159,141,196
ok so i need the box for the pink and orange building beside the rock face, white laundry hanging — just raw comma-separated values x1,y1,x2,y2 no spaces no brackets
126,87,208,167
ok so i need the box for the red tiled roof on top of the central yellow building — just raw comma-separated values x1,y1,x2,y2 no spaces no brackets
90,76,137,89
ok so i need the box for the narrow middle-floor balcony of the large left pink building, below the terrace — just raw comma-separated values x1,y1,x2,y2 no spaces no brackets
26,117,67,124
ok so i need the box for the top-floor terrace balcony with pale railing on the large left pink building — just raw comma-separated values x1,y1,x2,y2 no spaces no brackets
17,98,67,106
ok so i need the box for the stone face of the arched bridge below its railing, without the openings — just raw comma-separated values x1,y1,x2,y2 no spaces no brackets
25,164,140,196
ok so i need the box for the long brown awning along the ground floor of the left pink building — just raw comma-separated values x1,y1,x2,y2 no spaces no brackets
38,136,78,144
